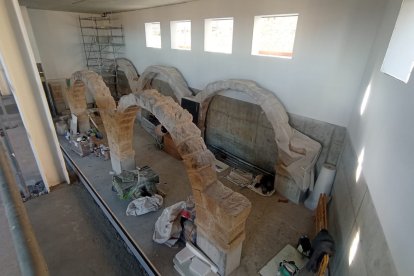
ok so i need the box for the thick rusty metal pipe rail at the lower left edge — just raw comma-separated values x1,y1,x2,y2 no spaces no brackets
0,139,49,276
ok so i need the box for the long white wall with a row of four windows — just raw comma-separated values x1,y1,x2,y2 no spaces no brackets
121,0,384,126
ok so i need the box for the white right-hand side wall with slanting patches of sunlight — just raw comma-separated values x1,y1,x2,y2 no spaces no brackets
349,0,414,275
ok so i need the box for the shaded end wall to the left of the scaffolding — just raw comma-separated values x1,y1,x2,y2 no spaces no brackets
28,9,90,79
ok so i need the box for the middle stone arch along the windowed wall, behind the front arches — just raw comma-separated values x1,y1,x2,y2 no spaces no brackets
137,65,193,103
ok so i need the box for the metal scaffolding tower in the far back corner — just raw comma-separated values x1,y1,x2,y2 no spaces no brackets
79,14,125,90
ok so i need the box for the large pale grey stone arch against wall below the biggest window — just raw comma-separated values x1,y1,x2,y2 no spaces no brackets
195,80,321,191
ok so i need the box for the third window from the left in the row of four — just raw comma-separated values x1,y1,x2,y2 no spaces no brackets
204,18,233,54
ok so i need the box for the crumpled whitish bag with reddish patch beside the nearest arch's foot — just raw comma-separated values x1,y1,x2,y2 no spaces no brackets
152,201,186,246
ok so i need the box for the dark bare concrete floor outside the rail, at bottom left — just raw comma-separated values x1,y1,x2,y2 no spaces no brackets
0,183,145,276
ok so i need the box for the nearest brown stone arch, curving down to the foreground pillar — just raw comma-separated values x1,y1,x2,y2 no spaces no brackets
117,89,251,275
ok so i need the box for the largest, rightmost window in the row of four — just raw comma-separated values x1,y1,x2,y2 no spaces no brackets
252,14,298,58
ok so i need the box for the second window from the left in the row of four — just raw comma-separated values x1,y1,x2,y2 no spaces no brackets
170,21,191,51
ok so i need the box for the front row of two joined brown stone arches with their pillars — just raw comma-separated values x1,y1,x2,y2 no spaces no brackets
71,71,251,275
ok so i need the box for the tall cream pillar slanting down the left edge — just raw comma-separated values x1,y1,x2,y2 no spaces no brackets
0,0,69,189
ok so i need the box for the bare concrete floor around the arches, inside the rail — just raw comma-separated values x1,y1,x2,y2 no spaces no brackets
60,125,313,275
